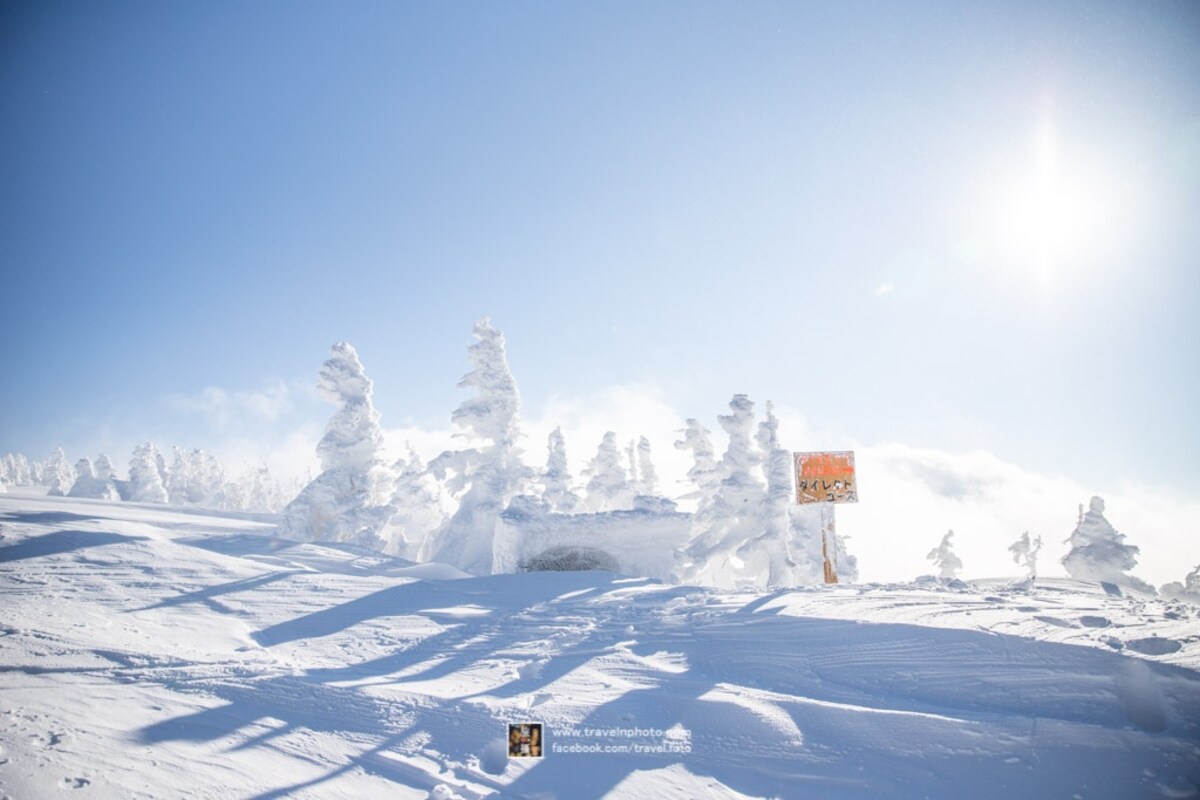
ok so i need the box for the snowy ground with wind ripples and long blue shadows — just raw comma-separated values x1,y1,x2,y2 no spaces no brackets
0,492,1200,800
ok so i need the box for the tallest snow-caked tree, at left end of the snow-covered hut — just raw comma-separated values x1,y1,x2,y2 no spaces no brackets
431,318,533,575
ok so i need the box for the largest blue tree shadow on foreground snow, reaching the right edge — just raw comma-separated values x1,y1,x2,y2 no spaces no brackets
131,573,1200,800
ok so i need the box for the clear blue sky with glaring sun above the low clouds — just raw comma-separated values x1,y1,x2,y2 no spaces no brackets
0,2,1200,507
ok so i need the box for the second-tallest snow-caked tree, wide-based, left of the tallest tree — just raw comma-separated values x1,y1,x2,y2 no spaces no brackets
274,342,388,548
